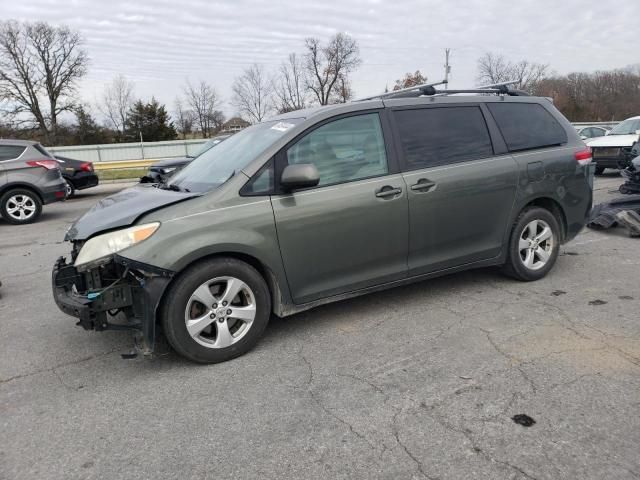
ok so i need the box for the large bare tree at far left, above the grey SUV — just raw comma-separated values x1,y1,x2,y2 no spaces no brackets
0,21,89,143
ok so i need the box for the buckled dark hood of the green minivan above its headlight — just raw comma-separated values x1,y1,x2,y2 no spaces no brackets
64,184,202,240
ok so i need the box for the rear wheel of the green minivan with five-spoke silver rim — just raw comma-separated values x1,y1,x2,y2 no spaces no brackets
502,207,560,282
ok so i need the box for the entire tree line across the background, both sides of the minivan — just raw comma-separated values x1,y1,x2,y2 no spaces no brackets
0,20,640,145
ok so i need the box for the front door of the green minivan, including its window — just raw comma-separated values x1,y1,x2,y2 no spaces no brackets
272,112,408,304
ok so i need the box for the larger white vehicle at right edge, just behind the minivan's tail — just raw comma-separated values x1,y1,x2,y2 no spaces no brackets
587,116,640,175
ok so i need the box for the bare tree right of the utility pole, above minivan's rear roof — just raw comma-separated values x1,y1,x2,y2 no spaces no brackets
476,53,549,90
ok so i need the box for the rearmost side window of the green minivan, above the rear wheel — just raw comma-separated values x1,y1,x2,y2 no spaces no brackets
487,103,567,152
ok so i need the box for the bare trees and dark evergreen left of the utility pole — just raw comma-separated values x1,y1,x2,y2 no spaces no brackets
0,20,361,145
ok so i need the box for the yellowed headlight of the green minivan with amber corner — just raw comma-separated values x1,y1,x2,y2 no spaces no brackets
74,222,160,268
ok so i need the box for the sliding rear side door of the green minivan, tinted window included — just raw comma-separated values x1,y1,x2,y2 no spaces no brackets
393,105,518,275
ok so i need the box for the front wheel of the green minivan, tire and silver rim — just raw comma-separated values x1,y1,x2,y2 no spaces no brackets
160,258,271,363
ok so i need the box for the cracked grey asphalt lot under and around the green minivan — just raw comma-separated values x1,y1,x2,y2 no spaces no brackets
0,175,640,480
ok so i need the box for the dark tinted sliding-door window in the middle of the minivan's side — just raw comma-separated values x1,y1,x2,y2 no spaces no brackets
394,107,493,170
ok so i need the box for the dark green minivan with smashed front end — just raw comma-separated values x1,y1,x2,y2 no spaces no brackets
52,87,593,363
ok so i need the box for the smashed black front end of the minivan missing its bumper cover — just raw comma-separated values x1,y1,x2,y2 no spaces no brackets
51,255,174,354
